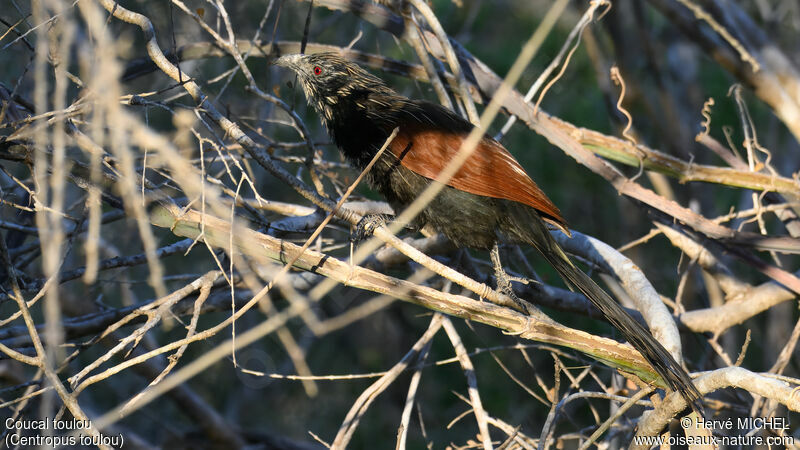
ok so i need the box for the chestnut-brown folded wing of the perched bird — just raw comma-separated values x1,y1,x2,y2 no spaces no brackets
388,125,569,233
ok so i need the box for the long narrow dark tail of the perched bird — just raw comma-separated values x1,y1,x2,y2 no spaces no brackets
530,214,702,414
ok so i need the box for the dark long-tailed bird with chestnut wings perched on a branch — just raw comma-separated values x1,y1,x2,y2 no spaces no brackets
273,52,701,411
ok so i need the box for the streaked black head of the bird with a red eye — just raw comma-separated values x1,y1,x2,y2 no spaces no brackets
273,53,397,124
